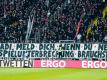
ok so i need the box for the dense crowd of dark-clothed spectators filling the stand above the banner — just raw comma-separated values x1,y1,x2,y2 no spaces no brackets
0,0,107,42
